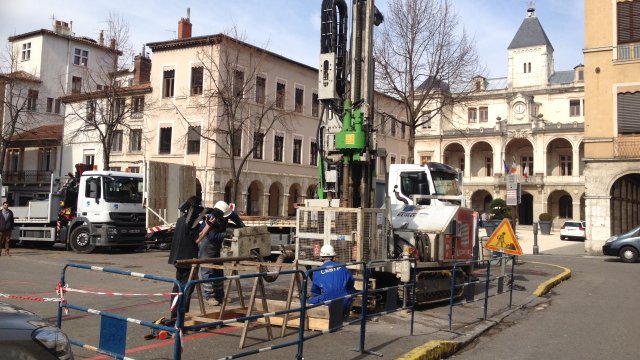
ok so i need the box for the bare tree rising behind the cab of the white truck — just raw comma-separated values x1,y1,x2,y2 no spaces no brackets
63,13,150,169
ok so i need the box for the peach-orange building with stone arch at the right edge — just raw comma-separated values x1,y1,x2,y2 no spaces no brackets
584,0,640,254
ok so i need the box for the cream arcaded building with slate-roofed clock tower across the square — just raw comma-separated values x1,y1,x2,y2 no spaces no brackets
414,8,585,224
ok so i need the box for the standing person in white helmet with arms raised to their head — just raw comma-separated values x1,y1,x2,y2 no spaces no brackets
196,201,244,306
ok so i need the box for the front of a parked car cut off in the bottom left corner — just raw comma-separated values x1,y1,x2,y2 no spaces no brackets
0,302,73,360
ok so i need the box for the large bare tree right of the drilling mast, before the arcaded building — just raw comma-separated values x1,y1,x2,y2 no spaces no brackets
375,0,481,163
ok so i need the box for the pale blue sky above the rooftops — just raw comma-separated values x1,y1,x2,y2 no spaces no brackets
0,0,584,78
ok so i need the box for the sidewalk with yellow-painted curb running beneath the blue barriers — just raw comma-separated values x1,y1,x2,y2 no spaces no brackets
284,253,568,360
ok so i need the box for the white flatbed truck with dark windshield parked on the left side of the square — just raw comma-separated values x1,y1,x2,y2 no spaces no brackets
12,164,146,253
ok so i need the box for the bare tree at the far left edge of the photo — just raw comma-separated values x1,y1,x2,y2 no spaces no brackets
0,43,41,198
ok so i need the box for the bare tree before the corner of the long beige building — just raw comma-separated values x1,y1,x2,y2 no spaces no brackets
176,28,291,202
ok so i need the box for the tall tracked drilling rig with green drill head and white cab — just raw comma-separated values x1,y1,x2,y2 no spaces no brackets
295,0,477,303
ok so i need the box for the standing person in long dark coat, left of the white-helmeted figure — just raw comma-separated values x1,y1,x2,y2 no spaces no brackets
169,196,203,324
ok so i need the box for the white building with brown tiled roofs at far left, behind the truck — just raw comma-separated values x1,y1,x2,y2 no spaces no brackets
0,20,118,205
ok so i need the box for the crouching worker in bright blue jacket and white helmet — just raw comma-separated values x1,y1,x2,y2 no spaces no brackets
309,244,356,310
